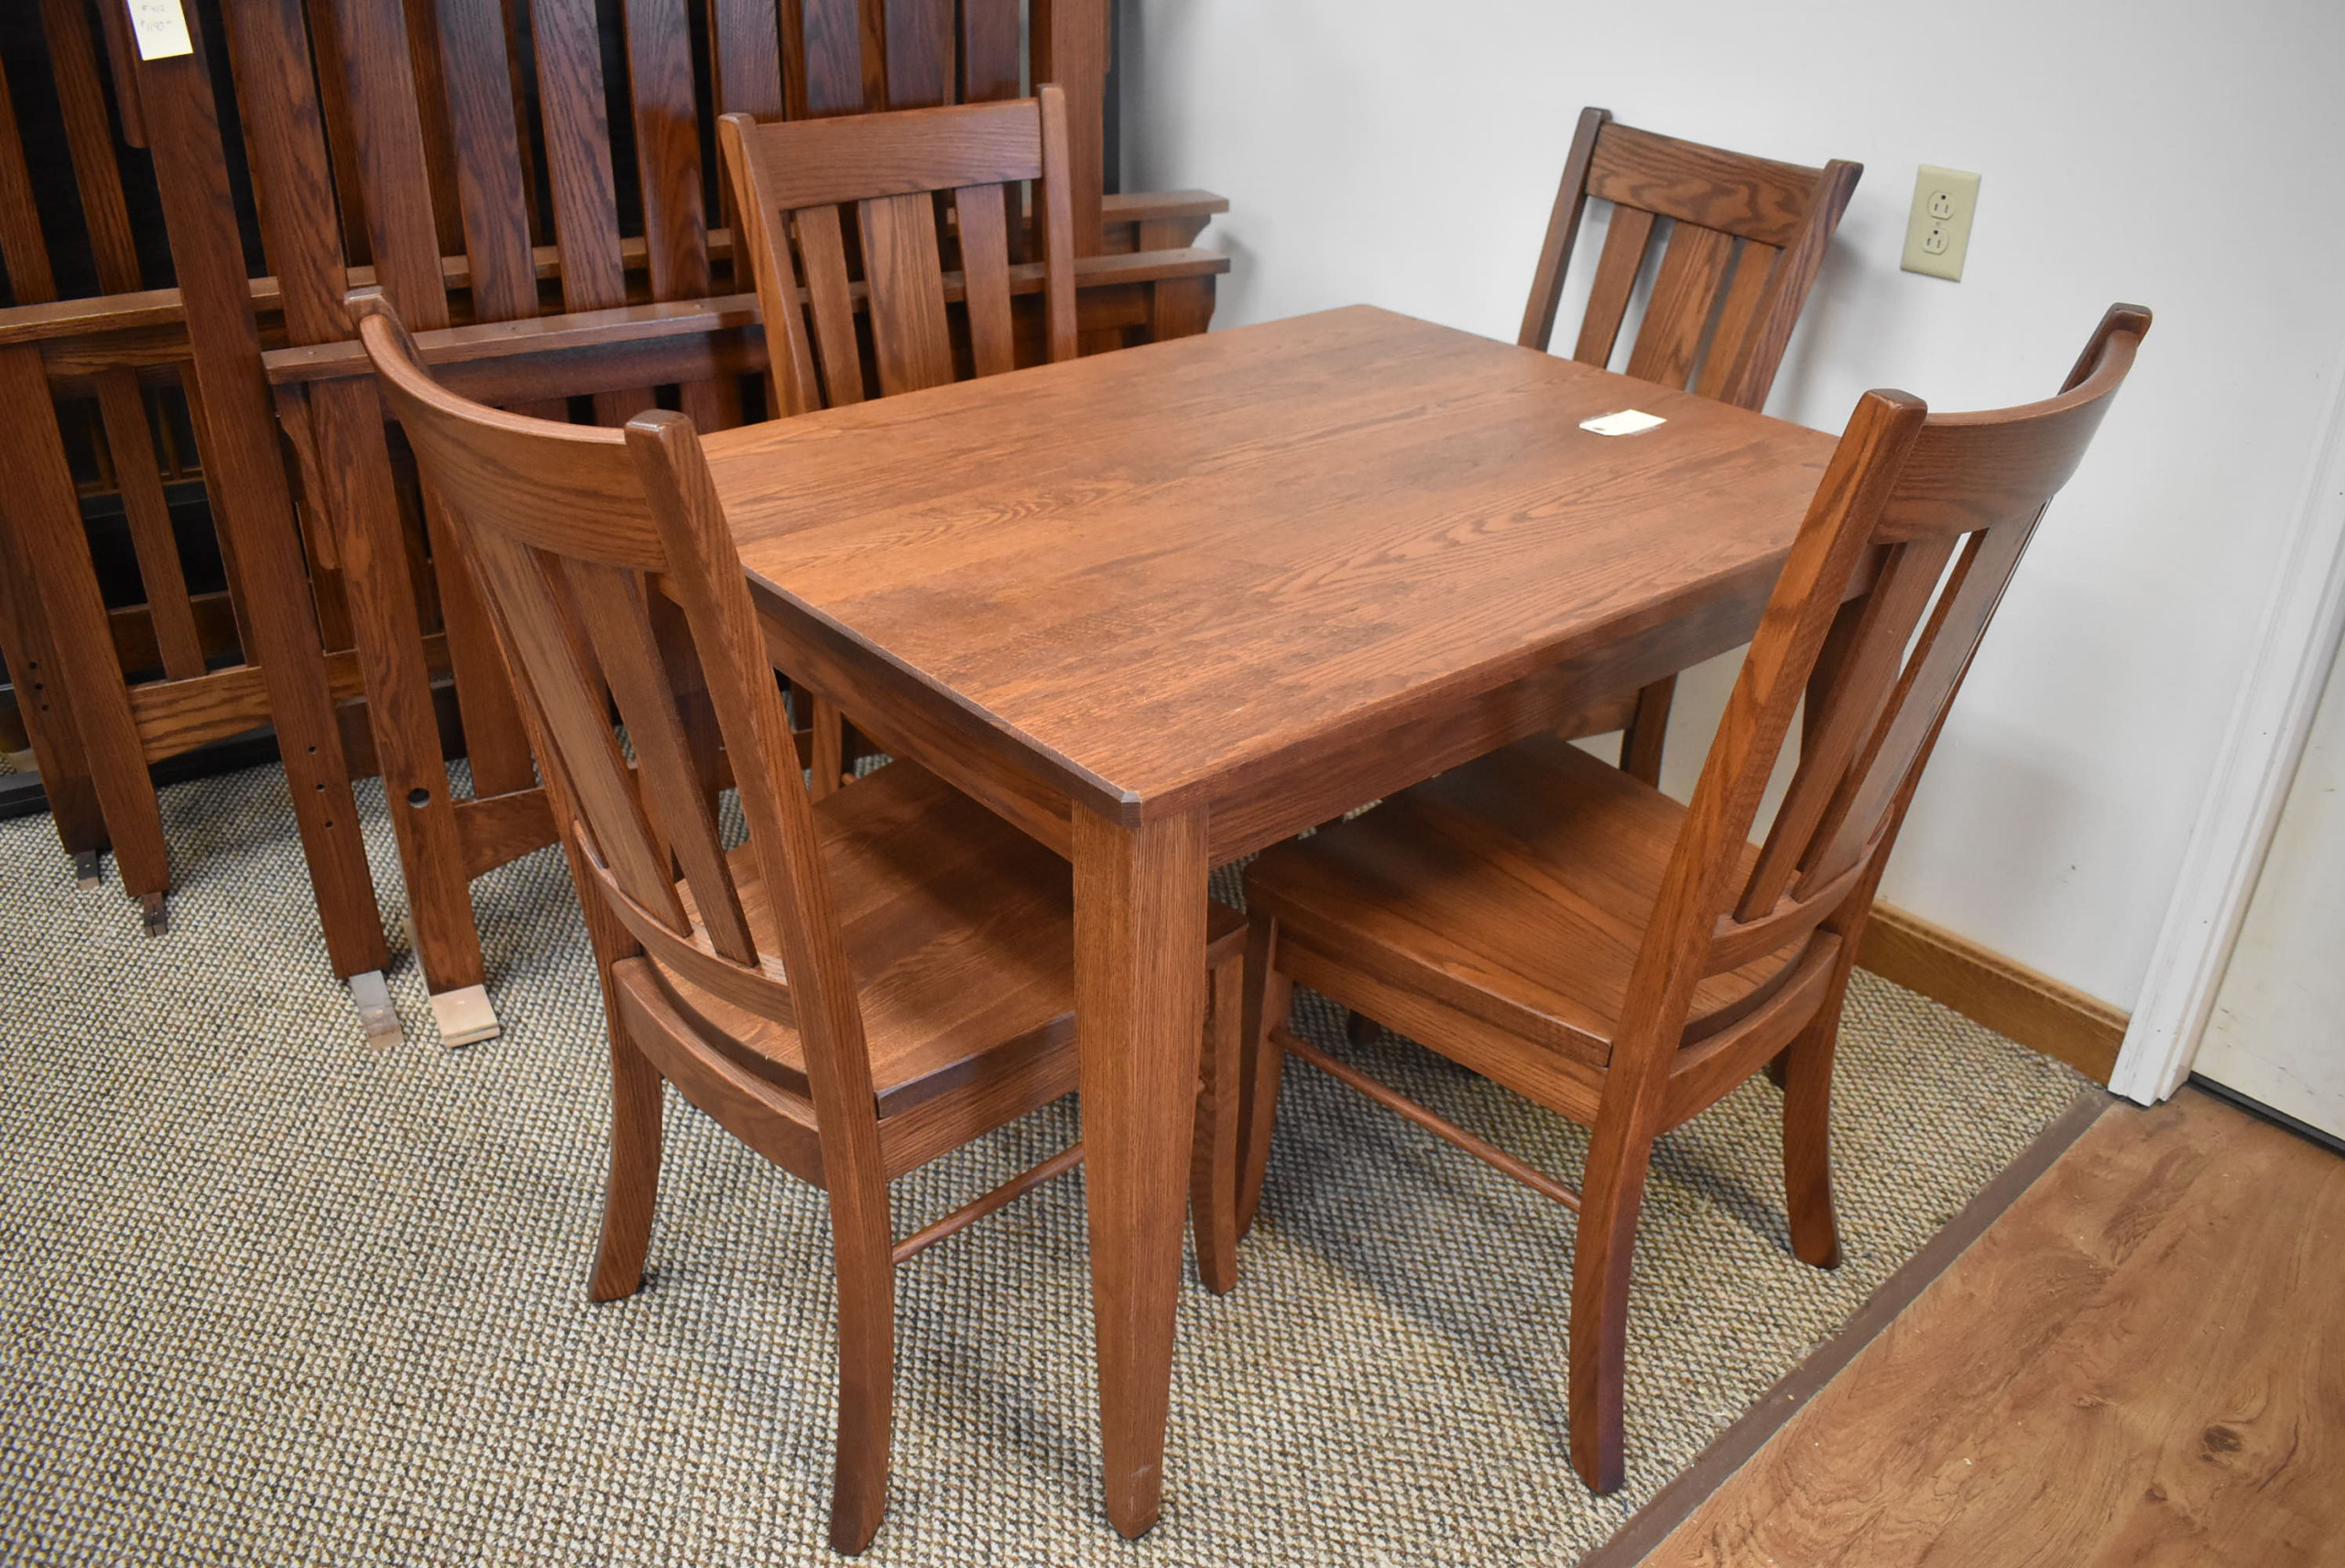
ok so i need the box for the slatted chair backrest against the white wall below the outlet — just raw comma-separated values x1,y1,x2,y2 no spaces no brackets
1517,108,1864,408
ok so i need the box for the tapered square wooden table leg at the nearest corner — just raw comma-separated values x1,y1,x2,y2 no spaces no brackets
1074,809,1207,1535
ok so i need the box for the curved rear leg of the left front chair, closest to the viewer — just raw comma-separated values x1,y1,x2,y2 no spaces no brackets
830,1191,896,1556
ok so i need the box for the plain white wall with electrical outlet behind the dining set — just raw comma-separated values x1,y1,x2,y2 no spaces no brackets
1118,0,2345,1006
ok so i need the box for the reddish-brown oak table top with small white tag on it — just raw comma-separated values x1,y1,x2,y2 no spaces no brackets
706,307,1834,837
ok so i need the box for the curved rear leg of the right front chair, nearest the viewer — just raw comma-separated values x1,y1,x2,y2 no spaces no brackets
1571,1116,1653,1493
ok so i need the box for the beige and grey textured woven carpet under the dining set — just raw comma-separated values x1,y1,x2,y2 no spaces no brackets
0,768,2078,1568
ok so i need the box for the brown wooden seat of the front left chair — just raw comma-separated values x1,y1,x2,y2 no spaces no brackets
659,762,1245,1118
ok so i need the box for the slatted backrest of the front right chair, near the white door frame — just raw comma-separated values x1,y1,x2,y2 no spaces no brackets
1637,305,2151,1034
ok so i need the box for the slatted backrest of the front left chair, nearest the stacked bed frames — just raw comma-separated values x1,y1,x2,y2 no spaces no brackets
349,289,872,1139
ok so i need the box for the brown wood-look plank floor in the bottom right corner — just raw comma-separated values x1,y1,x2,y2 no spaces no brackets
1644,1090,2345,1568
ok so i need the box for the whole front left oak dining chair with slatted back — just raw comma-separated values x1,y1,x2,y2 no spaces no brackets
349,290,1243,1552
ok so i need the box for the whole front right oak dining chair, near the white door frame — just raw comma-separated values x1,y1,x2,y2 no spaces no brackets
1215,305,2151,1491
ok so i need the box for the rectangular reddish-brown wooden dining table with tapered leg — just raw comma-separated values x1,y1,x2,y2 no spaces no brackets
706,307,1834,1535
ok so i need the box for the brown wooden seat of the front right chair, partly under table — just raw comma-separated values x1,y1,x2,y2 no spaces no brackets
1245,736,1801,1066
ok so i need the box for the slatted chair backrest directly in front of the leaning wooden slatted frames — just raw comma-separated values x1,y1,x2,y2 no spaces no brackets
720,84,1076,412
